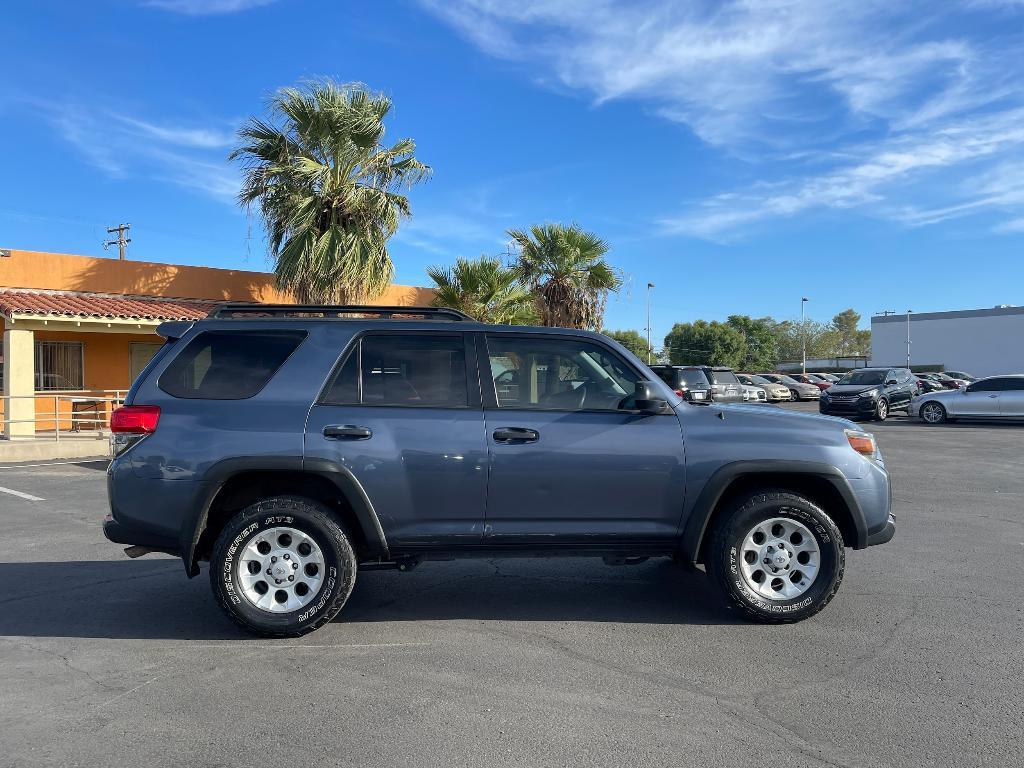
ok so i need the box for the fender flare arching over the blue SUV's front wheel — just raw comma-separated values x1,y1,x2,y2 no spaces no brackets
680,460,867,563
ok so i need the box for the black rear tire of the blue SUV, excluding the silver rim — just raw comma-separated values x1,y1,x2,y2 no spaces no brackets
210,496,356,637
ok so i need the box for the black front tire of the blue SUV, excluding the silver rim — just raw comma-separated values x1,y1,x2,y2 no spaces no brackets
705,488,846,624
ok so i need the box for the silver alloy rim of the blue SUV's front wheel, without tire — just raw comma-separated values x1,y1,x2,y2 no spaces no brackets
739,517,821,600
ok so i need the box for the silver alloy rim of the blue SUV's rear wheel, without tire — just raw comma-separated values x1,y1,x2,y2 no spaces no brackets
234,526,325,613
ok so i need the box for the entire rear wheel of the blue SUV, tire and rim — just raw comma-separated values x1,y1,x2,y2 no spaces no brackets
210,497,356,637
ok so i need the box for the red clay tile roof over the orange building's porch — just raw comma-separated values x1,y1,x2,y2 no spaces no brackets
0,291,215,321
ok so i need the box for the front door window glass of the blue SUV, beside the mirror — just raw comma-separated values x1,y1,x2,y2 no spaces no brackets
487,334,641,411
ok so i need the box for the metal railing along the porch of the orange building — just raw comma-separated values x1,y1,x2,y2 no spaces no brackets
0,389,127,442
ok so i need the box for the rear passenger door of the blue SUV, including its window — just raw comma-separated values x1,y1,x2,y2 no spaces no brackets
305,331,487,547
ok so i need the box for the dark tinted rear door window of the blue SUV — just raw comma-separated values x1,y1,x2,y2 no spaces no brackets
323,334,468,408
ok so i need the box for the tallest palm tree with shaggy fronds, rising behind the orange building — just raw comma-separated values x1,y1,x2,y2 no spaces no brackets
230,80,430,303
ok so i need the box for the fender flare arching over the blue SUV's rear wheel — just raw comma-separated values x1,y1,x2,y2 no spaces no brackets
180,456,389,578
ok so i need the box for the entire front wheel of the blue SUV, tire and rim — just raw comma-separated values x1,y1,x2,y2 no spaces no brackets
706,489,846,624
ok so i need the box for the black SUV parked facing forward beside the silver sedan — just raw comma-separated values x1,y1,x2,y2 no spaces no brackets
818,368,918,421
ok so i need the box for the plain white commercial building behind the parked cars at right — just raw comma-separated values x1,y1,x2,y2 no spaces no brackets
871,306,1024,376
